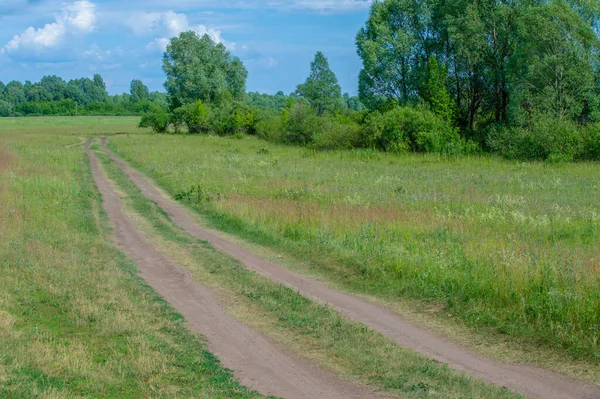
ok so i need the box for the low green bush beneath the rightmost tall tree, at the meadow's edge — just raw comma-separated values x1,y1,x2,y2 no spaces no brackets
487,115,586,162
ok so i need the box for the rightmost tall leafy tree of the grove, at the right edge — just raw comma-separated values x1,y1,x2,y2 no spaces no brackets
512,0,600,120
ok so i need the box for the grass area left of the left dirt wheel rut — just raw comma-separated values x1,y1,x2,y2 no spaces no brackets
0,130,261,398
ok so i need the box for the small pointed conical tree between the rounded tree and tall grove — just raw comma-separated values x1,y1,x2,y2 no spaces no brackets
296,51,342,116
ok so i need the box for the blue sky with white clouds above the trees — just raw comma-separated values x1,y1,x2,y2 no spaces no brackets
0,0,371,94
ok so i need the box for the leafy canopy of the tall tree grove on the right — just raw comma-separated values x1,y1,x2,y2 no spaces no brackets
356,0,600,135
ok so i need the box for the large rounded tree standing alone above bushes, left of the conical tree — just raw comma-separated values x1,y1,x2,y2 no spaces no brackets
163,31,248,109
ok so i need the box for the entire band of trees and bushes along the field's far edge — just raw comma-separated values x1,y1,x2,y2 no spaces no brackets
0,0,600,161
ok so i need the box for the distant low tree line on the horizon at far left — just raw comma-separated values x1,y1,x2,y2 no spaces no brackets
0,74,167,116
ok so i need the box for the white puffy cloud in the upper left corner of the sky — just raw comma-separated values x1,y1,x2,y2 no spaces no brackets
0,0,96,56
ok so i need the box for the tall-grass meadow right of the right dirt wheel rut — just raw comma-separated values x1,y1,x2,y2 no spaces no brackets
109,135,600,365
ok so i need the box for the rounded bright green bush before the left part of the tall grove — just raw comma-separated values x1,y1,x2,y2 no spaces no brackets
361,107,464,153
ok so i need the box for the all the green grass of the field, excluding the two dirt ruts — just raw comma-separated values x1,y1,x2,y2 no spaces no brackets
0,117,600,398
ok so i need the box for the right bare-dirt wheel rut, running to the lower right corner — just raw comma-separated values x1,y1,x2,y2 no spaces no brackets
102,139,600,399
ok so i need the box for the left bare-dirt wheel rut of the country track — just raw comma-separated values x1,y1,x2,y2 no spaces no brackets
86,141,378,399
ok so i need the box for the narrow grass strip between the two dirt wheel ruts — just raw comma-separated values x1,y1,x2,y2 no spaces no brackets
92,141,518,398
